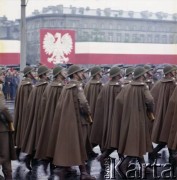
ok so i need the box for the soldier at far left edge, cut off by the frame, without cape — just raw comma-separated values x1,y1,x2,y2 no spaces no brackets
0,70,16,180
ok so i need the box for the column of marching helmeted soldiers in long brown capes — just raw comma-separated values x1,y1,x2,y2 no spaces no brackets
0,65,177,180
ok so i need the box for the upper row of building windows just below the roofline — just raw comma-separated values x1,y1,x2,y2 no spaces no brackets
27,19,177,32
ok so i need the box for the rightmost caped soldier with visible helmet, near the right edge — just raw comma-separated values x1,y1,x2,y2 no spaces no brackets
149,65,176,161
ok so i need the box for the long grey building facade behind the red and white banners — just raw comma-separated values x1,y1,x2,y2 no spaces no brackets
0,5,177,63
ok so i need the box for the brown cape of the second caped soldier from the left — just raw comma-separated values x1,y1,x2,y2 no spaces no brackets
22,80,48,154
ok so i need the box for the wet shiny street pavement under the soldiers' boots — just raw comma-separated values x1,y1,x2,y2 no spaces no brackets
0,101,177,180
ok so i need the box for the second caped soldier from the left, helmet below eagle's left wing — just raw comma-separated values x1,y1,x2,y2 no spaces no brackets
22,66,49,170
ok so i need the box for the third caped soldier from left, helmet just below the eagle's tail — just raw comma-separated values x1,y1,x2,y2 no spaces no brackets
35,66,66,172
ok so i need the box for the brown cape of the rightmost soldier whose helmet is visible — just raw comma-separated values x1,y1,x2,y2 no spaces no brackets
151,78,176,144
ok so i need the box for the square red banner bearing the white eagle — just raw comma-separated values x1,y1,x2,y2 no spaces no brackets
40,29,75,68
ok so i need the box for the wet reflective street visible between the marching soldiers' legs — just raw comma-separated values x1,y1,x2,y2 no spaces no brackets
0,101,176,180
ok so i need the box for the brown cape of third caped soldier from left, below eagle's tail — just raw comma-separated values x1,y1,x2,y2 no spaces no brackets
35,80,64,159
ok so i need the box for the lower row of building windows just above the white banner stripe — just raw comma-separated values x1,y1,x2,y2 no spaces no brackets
27,31,177,44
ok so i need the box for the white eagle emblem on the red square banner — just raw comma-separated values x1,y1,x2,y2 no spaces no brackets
43,32,73,64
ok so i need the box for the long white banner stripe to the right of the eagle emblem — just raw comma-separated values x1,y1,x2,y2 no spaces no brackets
75,42,177,55
